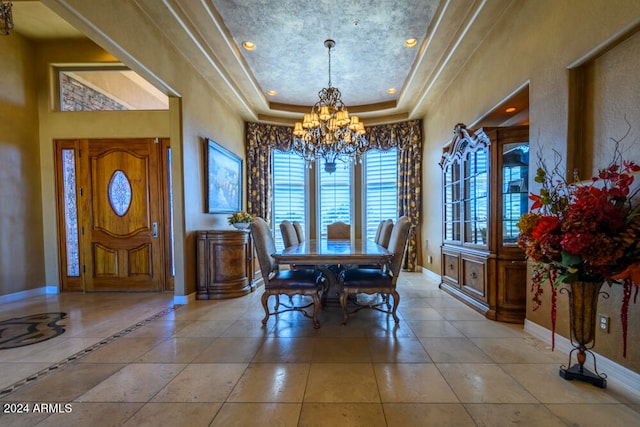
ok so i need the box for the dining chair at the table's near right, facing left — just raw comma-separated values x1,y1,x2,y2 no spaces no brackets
340,216,412,325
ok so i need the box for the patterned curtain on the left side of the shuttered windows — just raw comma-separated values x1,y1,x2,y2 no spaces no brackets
246,123,292,223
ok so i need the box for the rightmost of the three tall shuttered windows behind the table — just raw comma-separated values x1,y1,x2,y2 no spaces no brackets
363,148,398,240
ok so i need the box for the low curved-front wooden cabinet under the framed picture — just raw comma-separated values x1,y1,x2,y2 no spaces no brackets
196,230,256,299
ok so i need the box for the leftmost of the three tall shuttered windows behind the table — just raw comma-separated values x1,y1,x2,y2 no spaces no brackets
272,150,307,250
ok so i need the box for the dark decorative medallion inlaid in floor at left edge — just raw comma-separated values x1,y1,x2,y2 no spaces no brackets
0,312,67,350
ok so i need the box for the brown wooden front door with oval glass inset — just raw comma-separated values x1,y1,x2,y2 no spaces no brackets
58,138,169,291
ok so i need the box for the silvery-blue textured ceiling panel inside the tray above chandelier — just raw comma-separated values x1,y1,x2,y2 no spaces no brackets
213,0,438,105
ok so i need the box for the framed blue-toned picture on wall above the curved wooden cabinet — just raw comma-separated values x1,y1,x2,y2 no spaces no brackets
204,138,242,213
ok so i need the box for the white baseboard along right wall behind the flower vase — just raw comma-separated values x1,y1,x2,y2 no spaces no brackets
524,319,640,398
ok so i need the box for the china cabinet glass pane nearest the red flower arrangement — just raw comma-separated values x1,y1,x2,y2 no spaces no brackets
502,142,529,246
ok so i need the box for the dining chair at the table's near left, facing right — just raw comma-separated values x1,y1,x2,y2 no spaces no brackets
251,217,323,328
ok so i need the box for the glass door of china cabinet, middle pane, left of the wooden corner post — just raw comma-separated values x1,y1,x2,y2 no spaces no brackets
463,148,489,246
